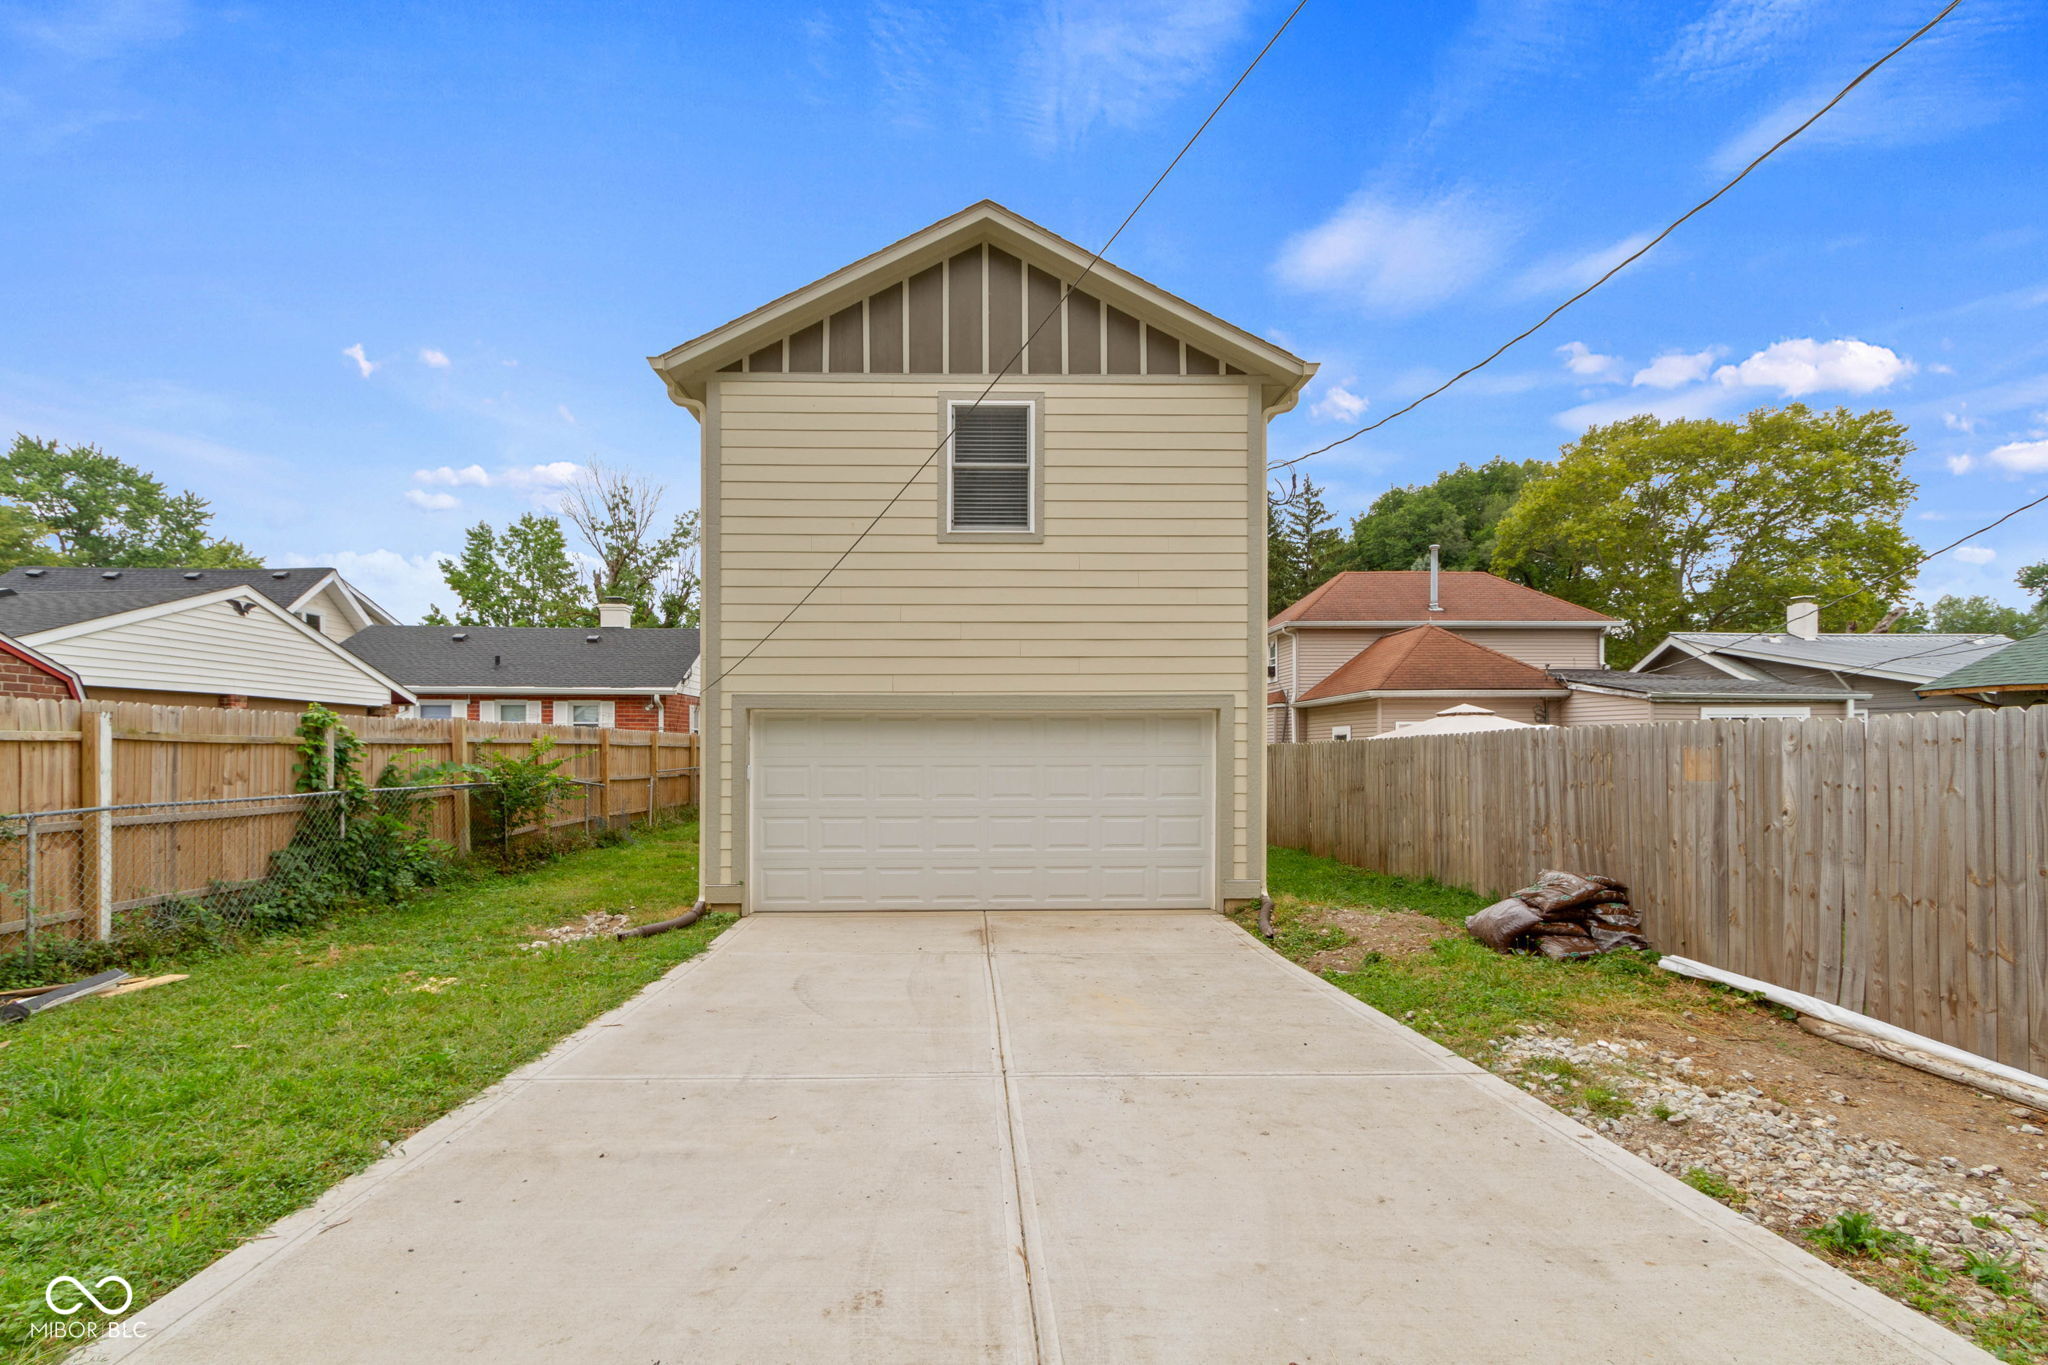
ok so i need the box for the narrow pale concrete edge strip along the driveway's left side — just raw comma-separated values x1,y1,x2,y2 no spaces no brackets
66,919,765,1365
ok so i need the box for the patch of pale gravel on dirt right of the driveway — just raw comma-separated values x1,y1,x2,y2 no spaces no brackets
1493,1025,2048,1310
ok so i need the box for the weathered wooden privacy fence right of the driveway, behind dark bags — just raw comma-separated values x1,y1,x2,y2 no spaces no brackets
1268,706,2048,1074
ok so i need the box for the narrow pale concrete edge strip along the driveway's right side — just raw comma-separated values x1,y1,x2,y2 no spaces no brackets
1251,939,1997,1365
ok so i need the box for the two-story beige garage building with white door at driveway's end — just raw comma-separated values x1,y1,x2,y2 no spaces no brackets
651,203,1315,911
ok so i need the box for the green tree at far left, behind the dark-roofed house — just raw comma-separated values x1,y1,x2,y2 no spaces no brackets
0,436,262,569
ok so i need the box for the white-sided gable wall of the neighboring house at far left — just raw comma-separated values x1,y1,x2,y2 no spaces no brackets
29,602,391,706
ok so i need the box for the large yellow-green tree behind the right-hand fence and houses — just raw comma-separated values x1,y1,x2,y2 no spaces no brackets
1493,403,1917,667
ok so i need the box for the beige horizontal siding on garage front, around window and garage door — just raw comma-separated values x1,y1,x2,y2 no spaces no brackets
705,376,1266,884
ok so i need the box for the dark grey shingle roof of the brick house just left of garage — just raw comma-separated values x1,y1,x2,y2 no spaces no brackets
342,626,696,692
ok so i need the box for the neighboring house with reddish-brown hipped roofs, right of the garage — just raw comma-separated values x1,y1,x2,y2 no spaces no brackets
1266,569,1622,741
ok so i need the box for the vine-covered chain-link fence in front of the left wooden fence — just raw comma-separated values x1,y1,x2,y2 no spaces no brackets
0,782,596,966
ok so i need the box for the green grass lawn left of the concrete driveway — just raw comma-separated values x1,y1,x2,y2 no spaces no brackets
0,823,731,1361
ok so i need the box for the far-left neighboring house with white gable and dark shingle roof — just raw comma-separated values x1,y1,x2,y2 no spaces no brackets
0,569,412,714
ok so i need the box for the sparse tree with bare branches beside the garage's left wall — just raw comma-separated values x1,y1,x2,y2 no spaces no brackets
561,465,696,626
